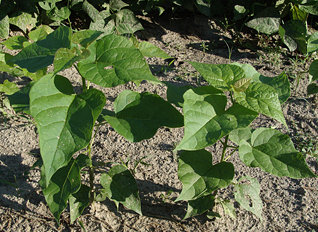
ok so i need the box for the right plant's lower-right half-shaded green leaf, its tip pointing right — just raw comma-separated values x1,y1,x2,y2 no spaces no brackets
239,128,315,178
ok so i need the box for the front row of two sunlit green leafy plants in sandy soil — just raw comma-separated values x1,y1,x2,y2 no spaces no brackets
0,26,318,227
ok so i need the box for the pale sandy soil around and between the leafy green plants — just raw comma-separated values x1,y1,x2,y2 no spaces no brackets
0,17,318,231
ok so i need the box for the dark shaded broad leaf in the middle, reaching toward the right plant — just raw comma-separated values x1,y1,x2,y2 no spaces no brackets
100,90,183,142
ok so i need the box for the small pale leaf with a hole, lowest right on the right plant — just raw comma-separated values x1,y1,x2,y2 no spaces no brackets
234,176,263,220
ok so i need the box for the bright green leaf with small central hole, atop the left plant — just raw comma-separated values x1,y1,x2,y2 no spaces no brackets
78,34,158,87
